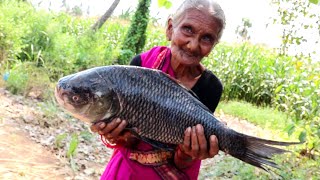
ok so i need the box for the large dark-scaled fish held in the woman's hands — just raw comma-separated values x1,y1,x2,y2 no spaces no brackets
55,66,298,170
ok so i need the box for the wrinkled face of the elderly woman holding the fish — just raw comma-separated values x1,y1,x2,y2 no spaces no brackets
167,9,221,65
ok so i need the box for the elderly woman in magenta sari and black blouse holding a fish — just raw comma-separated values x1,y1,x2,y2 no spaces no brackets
91,0,225,180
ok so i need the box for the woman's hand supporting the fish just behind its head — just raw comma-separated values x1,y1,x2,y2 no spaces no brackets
90,118,131,144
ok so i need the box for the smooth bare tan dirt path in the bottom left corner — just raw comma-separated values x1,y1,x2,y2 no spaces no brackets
0,120,72,179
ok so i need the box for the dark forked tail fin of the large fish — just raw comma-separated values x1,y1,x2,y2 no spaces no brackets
235,136,303,171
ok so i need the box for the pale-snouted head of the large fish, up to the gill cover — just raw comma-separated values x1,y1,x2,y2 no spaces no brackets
55,68,119,123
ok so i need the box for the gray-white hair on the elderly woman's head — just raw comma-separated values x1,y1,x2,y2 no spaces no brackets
171,0,226,42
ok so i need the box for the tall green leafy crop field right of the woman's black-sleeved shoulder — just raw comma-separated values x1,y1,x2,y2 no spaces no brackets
204,44,320,154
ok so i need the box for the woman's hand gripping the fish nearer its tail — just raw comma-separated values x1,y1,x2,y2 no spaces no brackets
175,124,219,168
